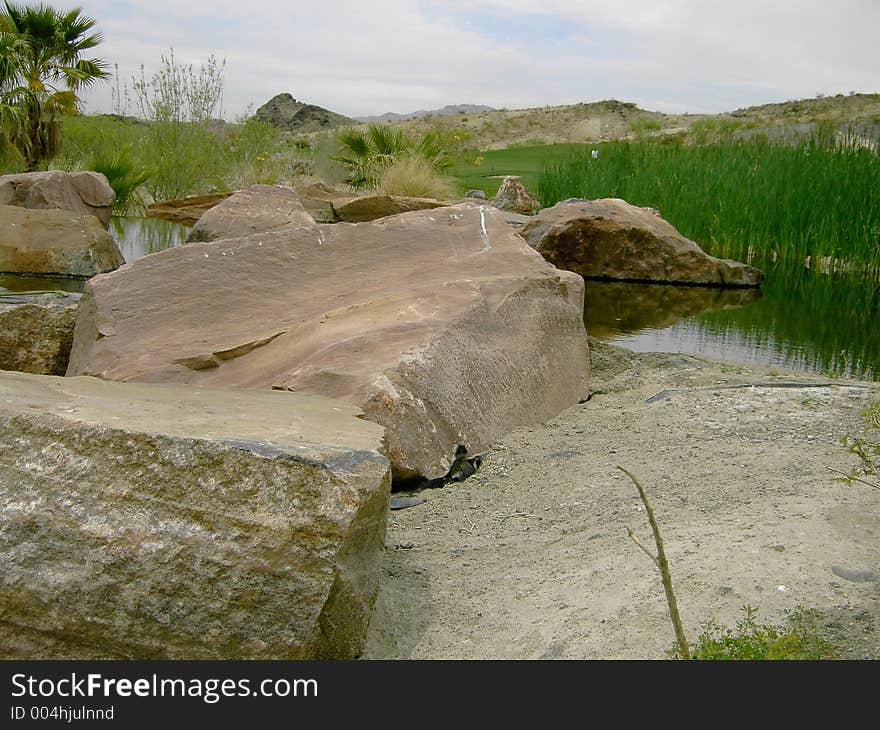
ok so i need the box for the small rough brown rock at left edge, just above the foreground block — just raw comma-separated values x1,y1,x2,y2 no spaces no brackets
0,292,80,375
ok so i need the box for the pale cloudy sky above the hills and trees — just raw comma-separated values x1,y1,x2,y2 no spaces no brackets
77,0,880,120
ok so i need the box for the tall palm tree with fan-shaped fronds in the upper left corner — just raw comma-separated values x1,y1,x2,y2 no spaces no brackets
0,0,109,172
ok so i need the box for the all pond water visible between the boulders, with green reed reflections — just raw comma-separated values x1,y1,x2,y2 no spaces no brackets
0,217,880,380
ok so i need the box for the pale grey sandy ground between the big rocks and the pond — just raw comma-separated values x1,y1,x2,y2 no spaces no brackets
363,341,880,659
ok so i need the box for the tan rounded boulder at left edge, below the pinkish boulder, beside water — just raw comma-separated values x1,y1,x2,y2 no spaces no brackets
0,205,125,278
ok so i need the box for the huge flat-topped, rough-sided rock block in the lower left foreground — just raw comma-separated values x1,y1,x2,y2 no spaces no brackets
0,373,389,659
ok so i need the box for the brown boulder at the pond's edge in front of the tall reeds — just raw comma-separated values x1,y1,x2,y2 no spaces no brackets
520,198,763,287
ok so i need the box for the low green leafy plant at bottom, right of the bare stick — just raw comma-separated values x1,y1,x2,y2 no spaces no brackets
669,606,836,661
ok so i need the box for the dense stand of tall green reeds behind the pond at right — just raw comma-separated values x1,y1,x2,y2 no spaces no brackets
537,135,880,278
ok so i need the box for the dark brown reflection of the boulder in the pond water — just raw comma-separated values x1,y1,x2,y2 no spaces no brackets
584,281,761,338
